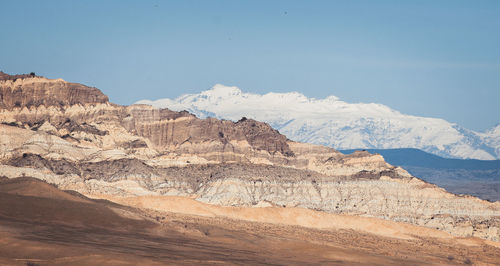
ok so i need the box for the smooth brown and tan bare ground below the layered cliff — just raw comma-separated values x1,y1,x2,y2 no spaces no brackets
0,178,500,265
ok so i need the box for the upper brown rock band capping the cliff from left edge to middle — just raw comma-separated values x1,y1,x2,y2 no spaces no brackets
0,75,293,161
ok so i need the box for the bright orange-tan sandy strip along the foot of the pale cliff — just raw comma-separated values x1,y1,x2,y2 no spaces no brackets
102,195,500,247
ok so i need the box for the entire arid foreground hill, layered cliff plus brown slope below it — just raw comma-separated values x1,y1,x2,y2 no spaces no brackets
0,74,500,265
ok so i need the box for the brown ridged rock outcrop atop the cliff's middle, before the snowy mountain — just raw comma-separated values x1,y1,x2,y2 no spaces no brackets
123,106,293,156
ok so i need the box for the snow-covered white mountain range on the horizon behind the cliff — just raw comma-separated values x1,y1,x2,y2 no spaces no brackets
137,84,500,160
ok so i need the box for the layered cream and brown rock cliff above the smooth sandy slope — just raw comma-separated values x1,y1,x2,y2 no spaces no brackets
0,74,500,241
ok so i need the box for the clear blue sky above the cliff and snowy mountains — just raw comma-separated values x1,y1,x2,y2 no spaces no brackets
0,0,500,130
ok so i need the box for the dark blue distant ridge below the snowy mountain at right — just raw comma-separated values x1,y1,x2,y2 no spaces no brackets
340,149,500,201
